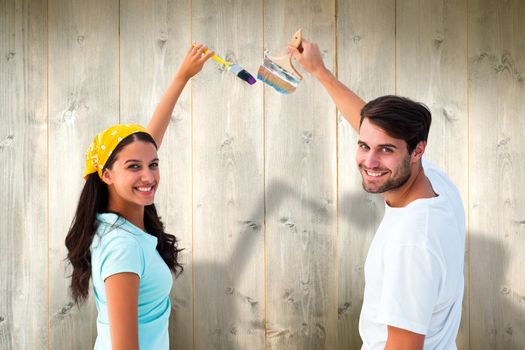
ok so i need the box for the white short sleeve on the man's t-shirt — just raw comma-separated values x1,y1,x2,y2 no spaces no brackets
378,245,442,334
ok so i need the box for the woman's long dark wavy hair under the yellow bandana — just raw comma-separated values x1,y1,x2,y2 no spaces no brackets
66,132,183,304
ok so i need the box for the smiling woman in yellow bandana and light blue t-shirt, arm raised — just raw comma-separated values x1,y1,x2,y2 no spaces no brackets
66,45,213,349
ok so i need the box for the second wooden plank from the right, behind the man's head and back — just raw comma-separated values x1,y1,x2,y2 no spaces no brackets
396,0,469,349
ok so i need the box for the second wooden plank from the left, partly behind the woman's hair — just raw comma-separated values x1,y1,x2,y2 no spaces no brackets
48,0,119,349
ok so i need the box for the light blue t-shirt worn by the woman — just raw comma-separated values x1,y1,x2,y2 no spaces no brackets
90,213,173,350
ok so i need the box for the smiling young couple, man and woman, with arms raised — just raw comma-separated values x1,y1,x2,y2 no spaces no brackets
66,40,465,349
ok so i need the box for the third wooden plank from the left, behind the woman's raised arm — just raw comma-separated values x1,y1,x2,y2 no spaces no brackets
120,0,193,349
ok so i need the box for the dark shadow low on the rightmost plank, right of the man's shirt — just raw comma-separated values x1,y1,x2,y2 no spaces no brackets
469,232,525,350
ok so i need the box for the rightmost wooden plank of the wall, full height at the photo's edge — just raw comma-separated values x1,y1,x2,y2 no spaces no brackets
468,0,525,350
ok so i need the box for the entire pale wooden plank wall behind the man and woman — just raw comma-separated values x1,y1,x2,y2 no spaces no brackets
0,0,525,350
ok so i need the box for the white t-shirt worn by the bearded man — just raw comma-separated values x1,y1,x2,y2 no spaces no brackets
359,161,466,350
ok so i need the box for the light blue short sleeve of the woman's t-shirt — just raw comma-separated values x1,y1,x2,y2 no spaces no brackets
100,232,144,281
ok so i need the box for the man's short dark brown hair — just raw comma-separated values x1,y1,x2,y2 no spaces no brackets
359,95,432,153
